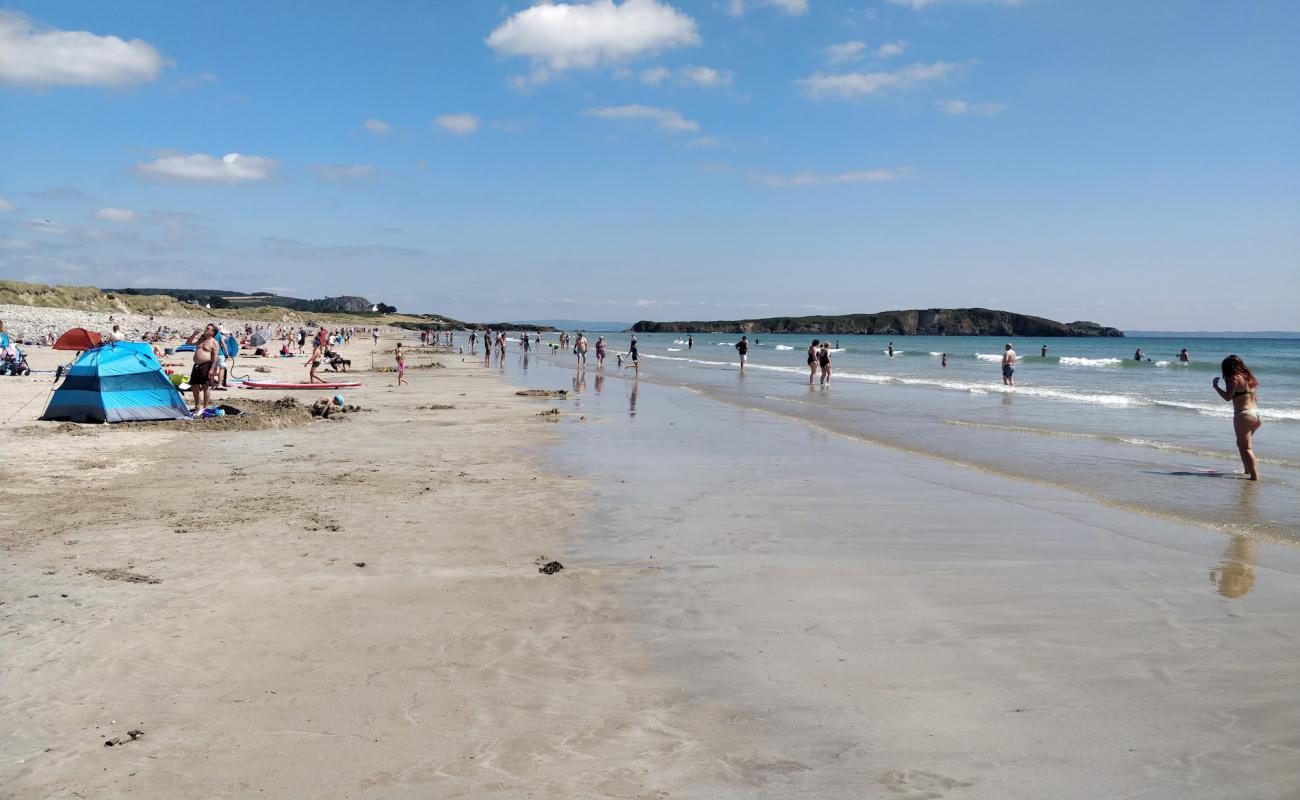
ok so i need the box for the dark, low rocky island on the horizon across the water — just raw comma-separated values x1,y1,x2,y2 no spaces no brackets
632,308,1125,337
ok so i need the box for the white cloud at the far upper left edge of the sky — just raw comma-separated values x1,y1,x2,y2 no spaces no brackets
0,12,166,87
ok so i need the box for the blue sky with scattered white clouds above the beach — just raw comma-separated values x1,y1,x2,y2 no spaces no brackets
0,0,1300,329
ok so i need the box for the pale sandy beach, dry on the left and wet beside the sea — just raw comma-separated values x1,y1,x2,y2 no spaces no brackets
0,334,1300,800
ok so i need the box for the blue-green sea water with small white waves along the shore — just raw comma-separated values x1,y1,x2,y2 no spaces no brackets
520,334,1300,544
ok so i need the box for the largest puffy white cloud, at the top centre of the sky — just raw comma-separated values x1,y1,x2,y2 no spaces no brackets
488,0,699,87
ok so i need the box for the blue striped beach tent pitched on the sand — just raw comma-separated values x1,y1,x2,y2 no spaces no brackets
40,342,191,423
